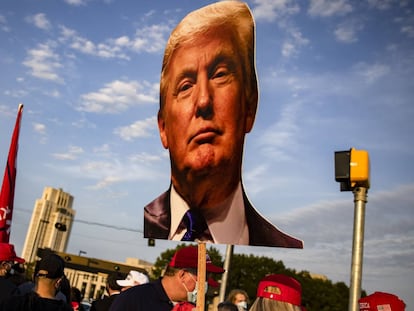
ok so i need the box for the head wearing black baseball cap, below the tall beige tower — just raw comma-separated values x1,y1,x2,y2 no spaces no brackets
34,254,65,298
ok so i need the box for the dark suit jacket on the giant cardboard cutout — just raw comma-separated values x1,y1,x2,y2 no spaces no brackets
144,189,303,248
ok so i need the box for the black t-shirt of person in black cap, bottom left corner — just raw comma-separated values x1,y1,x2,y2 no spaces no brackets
0,292,73,311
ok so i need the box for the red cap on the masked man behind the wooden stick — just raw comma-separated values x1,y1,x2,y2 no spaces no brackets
168,246,224,273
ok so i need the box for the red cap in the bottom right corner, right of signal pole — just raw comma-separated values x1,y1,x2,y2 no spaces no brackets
358,292,405,311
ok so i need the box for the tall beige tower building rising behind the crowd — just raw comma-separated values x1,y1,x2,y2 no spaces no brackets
22,187,76,262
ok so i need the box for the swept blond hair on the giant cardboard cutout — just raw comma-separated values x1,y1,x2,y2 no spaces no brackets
160,1,258,112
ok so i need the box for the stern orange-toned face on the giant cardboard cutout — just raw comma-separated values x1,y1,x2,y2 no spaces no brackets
158,29,257,182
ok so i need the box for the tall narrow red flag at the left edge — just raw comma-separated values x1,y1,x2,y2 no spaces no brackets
0,104,23,243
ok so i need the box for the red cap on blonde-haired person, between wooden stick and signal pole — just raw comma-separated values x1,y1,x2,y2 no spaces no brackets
257,274,302,306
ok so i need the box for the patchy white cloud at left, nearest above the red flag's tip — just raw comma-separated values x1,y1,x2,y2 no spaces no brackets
23,44,63,83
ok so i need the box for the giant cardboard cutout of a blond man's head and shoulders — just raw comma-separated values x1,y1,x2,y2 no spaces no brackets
144,1,303,248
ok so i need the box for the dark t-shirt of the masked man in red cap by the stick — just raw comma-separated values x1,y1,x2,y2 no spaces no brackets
109,279,173,311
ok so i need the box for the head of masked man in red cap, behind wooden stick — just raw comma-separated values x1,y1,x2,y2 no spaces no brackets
163,246,224,303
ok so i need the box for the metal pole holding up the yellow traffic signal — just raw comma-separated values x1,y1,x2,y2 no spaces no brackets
348,187,368,311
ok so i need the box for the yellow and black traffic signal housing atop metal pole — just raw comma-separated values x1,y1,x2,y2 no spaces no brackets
335,148,370,191
